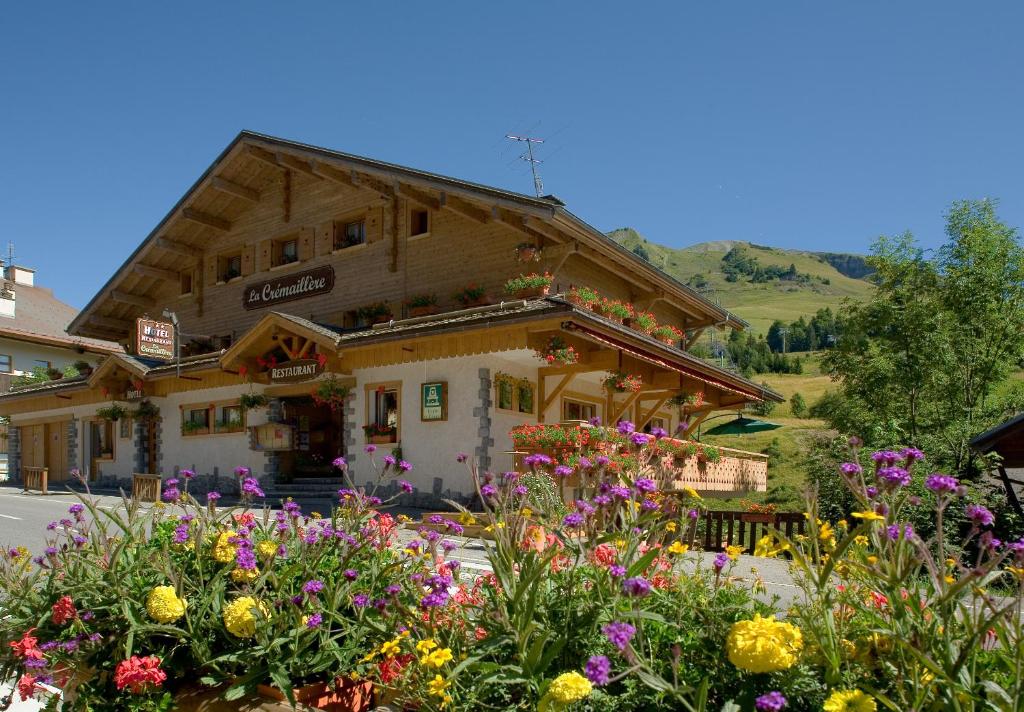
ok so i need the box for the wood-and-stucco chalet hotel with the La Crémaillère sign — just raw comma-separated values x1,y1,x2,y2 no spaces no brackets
0,132,781,498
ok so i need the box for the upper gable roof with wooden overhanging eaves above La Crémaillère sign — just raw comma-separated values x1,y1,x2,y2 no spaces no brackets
68,131,746,339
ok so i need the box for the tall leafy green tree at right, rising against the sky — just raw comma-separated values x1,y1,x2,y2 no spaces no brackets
816,201,1024,474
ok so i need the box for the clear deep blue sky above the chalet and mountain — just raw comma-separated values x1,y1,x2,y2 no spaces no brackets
0,1,1024,306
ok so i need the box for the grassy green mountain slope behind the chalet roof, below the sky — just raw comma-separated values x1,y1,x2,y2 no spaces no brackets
608,227,872,333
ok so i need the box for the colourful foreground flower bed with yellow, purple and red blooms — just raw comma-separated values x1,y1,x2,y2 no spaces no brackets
0,442,1024,712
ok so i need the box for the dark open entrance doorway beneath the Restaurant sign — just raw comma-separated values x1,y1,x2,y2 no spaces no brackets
281,396,345,478
